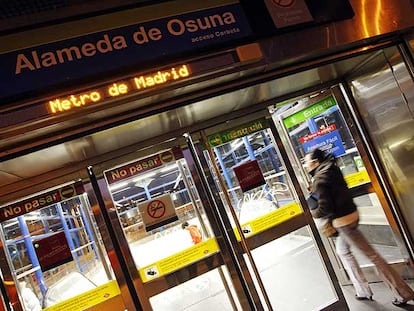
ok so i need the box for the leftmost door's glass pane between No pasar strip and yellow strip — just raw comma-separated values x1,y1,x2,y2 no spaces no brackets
1,195,112,310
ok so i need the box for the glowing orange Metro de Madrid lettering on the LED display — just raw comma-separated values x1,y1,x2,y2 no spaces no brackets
47,65,191,114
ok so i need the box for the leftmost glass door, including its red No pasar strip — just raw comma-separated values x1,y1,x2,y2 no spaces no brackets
0,181,126,311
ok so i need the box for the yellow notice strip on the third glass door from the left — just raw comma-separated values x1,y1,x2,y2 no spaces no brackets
233,202,303,241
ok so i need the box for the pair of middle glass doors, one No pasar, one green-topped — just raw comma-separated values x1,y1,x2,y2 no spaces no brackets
90,115,345,310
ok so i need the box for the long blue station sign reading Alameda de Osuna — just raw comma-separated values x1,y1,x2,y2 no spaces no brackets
0,4,252,99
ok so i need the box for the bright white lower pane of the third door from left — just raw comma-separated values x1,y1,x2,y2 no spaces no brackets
247,227,337,311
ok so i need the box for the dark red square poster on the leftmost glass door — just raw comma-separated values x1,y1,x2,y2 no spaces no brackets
33,231,73,271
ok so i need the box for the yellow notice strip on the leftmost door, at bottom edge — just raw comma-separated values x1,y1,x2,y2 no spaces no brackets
43,281,121,311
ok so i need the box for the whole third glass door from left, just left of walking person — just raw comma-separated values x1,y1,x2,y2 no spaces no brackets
193,114,347,310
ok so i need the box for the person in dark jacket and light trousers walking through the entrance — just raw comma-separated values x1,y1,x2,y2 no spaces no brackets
304,149,414,306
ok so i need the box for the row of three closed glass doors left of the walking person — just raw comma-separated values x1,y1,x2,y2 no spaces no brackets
1,117,346,310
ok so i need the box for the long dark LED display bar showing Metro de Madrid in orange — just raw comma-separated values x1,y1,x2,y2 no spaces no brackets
0,50,239,128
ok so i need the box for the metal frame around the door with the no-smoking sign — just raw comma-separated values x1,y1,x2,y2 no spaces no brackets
87,135,263,310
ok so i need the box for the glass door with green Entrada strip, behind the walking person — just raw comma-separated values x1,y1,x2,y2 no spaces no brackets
272,87,407,281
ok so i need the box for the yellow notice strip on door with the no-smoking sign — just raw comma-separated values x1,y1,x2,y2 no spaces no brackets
139,238,219,283
